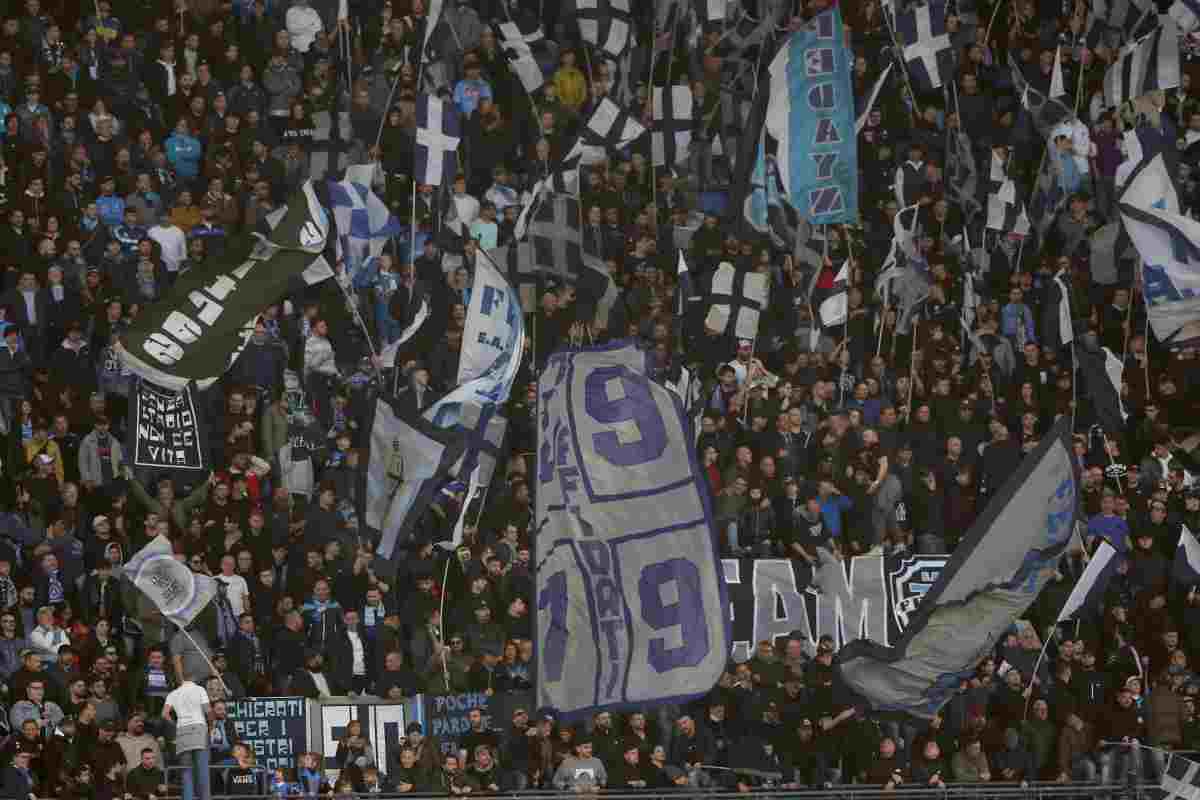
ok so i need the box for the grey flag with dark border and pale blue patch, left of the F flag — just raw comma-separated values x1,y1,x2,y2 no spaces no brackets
359,396,467,573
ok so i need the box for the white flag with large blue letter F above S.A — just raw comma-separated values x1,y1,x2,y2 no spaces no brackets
457,249,524,395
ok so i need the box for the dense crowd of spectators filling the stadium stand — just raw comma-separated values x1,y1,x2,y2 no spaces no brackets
0,0,1200,800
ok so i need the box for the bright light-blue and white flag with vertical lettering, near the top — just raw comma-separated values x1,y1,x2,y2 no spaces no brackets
763,6,858,224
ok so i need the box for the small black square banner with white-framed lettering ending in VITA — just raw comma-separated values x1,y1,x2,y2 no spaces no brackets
133,380,205,470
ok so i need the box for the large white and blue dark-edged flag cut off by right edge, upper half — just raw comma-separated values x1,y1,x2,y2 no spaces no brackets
1118,154,1200,345
